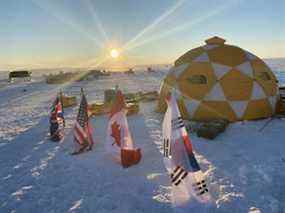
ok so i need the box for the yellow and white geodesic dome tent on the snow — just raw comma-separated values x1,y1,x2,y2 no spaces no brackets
158,37,278,122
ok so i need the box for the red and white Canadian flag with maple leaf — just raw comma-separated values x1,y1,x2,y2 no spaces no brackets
106,91,141,168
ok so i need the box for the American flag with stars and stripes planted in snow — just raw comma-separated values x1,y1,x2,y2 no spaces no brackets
72,91,94,154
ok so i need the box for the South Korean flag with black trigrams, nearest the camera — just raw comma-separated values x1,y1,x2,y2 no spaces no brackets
162,92,211,207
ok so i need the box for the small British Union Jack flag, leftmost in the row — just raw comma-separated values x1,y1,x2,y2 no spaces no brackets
49,96,65,141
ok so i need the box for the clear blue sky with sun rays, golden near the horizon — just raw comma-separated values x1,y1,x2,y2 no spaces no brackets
0,0,285,70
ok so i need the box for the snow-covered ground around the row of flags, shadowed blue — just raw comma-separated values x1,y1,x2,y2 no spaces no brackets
0,63,285,213
